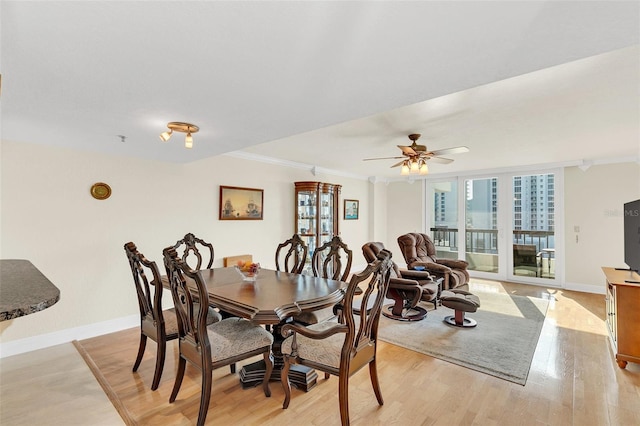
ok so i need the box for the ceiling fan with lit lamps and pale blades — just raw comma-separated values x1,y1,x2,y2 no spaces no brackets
364,133,469,175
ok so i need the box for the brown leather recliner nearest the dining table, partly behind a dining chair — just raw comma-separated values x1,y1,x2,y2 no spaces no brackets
362,242,440,321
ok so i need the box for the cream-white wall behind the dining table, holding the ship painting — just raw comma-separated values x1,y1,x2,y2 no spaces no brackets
0,141,372,356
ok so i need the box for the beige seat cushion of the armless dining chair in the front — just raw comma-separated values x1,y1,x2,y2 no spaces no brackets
207,317,273,363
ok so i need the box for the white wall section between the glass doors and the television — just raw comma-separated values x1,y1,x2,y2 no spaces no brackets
564,163,640,293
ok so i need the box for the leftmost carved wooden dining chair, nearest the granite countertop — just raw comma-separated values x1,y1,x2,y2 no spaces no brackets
124,242,221,390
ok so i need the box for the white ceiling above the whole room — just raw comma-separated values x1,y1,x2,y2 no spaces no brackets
0,0,640,178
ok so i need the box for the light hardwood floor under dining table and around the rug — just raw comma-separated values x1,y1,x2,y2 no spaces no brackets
2,278,640,426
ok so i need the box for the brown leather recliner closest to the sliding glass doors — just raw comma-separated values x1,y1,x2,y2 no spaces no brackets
398,232,469,290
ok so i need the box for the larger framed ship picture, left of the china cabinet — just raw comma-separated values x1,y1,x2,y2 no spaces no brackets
219,185,264,220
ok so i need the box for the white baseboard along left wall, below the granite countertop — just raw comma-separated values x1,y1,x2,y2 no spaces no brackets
0,315,140,358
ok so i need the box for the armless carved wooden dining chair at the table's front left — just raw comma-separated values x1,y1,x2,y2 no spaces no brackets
163,247,273,426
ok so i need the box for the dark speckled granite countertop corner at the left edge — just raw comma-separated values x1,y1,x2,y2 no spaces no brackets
0,259,60,321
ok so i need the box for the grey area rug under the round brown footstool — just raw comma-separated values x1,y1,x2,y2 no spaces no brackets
378,291,549,385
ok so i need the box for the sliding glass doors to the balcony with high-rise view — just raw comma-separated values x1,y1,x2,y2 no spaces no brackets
426,172,562,285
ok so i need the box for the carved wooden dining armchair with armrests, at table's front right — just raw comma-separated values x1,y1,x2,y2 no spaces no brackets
280,250,391,425
